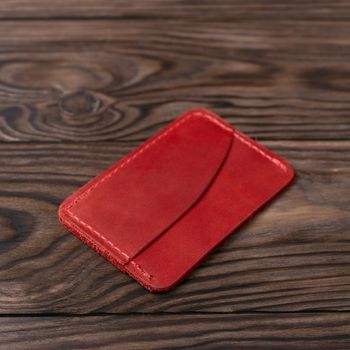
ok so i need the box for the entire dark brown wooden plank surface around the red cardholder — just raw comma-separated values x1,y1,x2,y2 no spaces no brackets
0,0,350,350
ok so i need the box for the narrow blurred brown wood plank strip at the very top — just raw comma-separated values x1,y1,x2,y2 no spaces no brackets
0,0,350,21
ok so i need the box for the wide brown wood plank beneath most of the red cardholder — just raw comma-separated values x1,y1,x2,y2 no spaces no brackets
0,141,350,313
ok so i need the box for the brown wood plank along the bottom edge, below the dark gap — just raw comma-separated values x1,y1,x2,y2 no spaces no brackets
0,313,350,350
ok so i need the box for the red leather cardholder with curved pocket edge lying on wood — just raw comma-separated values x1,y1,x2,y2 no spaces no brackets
59,109,294,292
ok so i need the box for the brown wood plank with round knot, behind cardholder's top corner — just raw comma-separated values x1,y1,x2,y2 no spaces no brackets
0,20,350,141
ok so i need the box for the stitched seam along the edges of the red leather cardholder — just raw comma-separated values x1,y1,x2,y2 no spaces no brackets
65,111,286,280
